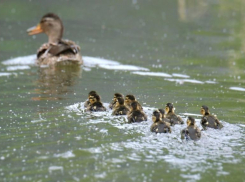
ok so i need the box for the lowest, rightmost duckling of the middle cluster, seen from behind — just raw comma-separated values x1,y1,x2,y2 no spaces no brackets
128,101,147,123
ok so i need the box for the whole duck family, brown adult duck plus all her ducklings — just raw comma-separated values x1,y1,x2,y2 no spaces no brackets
27,13,223,140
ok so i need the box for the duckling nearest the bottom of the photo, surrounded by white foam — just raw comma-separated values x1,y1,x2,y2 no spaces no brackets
181,116,201,140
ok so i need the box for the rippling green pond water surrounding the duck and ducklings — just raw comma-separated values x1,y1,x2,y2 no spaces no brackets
0,0,245,182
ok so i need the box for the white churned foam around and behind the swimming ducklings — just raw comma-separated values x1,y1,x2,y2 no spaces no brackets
66,103,245,178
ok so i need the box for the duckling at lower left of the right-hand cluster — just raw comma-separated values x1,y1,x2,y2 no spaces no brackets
151,110,171,133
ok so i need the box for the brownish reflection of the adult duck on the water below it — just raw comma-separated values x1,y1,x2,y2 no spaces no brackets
32,65,82,100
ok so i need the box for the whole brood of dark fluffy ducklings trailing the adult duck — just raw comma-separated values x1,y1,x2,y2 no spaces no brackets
84,91,223,140
